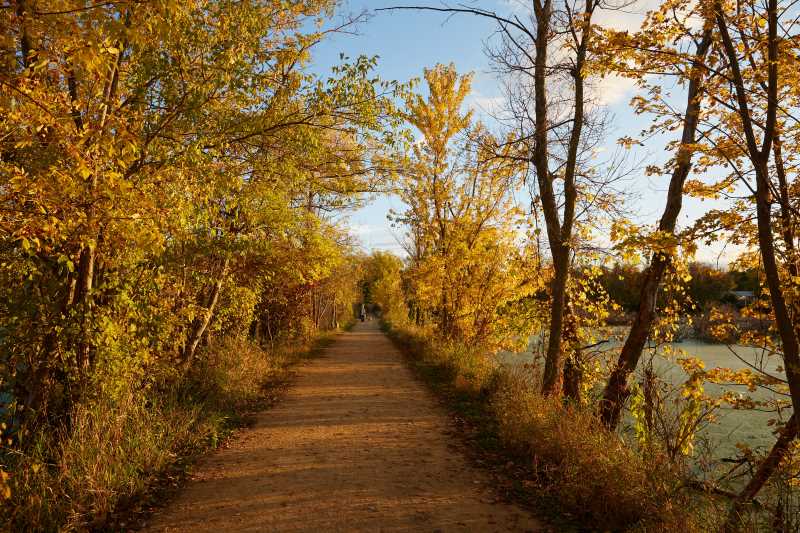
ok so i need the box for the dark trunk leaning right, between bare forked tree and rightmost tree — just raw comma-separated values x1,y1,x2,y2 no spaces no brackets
600,28,712,429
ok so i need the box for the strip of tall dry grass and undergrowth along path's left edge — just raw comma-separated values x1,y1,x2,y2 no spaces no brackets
0,336,330,531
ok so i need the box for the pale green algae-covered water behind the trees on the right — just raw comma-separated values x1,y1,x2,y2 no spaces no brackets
501,340,788,458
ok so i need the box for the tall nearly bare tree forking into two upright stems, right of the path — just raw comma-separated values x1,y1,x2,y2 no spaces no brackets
390,0,600,395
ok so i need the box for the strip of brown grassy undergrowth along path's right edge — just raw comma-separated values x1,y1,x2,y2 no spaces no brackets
384,324,724,532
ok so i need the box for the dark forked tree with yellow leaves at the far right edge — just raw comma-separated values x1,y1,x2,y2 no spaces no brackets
692,0,800,516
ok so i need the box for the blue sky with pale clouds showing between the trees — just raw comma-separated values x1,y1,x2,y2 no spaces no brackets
312,0,730,263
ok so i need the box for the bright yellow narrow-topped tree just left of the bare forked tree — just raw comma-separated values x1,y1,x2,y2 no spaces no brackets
394,65,533,348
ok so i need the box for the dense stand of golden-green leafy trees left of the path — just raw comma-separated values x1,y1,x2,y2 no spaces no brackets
0,0,396,432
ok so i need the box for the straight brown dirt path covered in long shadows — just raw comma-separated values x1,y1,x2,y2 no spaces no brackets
145,322,543,533
